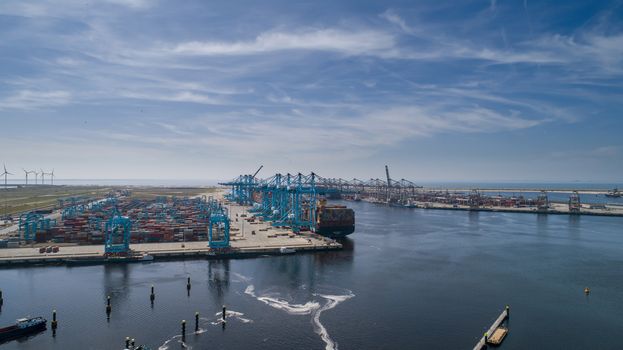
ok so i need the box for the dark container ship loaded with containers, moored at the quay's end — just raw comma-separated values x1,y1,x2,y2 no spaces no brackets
316,199,355,238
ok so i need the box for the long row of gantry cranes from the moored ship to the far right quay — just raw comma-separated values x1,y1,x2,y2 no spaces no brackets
221,165,581,216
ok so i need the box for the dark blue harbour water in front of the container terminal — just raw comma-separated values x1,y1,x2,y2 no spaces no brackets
0,202,623,349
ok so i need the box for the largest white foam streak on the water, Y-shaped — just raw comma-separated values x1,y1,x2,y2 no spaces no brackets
243,285,355,350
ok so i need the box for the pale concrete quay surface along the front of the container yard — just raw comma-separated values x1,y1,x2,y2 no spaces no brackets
0,204,342,266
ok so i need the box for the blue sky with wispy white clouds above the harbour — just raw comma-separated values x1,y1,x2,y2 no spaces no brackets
0,0,623,182
